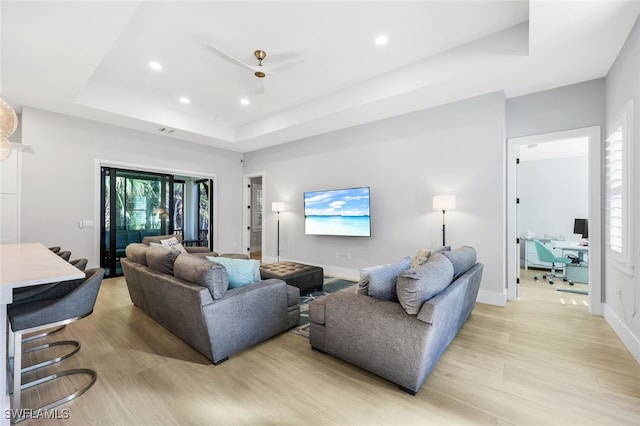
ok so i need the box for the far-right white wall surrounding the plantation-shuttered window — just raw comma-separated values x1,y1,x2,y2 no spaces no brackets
604,15,640,362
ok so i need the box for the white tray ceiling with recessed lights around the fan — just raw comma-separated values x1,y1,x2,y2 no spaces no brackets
0,0,640,152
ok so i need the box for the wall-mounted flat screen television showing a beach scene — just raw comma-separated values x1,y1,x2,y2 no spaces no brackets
304,186,371,237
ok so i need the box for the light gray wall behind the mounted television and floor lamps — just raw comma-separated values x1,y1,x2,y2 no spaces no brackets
245,93,505,304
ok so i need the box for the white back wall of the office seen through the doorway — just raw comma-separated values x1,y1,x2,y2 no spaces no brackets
518,156,589,240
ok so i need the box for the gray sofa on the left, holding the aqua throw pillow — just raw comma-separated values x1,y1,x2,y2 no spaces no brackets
122,244,300,365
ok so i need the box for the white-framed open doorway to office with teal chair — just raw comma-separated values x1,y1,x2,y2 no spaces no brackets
507,127,602,315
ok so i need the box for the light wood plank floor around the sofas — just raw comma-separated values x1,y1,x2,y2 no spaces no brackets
17,272,640,426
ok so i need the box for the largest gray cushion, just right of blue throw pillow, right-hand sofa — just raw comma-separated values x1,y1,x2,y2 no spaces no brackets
396,253,453,315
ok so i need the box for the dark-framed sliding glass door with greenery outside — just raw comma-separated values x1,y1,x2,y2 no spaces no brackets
100,167,213,277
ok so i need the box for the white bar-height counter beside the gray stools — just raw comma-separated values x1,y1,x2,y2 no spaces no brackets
0,243,84,425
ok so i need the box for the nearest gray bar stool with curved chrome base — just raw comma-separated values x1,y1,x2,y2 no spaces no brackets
7,268,104,423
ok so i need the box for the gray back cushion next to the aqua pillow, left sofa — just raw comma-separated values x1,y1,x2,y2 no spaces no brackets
173,253,229,299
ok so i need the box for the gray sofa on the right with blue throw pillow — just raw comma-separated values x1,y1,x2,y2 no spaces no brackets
309,247,483,395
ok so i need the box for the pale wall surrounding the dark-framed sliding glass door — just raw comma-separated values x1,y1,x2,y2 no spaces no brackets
21,107,242,266
